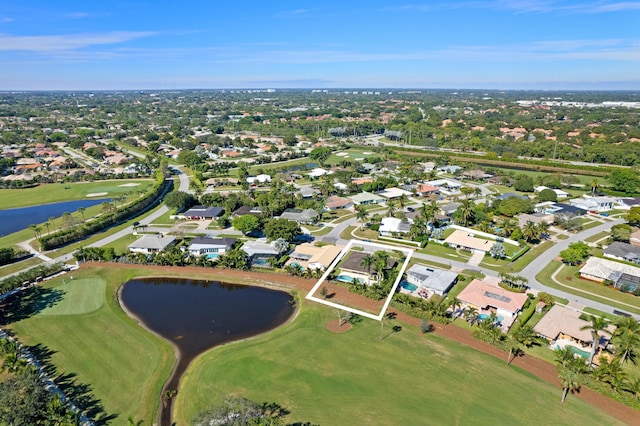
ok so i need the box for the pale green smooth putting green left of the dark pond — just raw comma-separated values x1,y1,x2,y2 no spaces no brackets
40,276,107,315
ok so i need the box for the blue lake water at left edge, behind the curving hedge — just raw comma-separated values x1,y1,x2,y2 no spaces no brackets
0,198,111,237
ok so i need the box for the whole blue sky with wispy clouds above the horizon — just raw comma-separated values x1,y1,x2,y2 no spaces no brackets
0,0,640,90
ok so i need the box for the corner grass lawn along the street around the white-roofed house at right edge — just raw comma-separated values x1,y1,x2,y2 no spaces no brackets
536,261,640,314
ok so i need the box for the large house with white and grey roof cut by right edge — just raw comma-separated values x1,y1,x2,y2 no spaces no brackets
579,257,640,292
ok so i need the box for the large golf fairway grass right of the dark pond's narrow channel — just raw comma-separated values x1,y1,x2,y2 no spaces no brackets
174,306,619,425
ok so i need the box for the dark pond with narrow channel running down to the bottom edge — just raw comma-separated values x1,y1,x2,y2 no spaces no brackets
120,278,294,425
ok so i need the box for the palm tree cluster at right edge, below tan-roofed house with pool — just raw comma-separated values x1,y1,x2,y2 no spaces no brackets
556,316,640,402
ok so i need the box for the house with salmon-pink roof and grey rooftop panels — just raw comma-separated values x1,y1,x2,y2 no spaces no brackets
458,279,528,318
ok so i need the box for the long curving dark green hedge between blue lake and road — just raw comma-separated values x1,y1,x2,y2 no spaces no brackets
39,172,173,250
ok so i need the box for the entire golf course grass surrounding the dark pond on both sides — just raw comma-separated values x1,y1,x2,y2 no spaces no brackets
9,264,632,425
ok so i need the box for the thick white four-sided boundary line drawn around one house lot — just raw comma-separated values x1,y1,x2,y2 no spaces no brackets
305,240,413,321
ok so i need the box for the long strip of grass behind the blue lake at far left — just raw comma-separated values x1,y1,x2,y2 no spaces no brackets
0,179,153,209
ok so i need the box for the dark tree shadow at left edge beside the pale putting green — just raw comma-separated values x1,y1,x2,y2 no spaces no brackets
0,286,65,325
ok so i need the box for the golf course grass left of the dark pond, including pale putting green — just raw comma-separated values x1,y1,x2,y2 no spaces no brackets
8,267,174,424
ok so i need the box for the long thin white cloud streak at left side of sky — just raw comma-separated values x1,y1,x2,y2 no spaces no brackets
0,31,155,53
